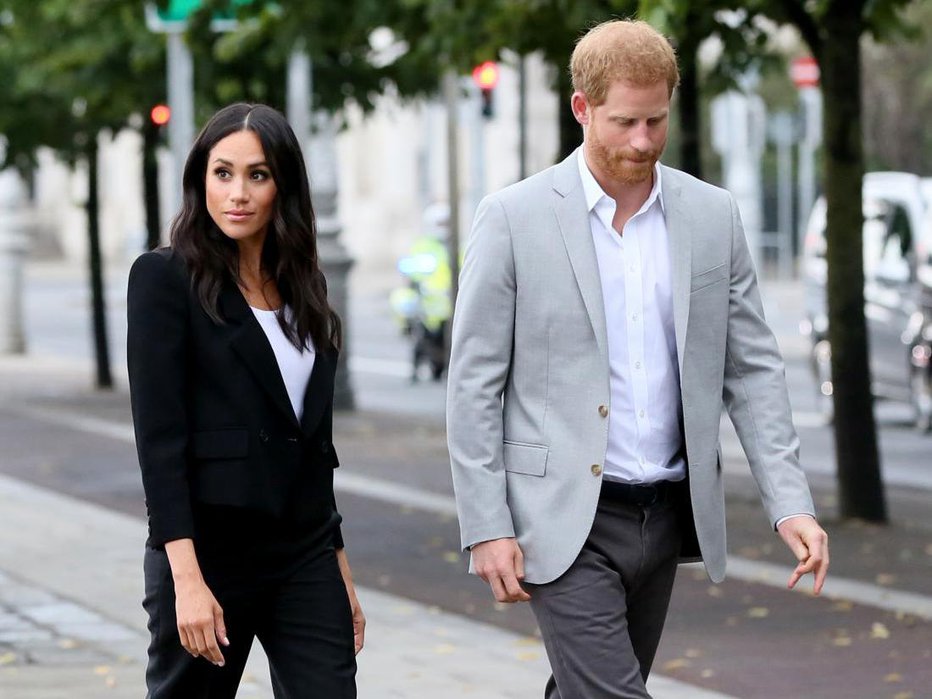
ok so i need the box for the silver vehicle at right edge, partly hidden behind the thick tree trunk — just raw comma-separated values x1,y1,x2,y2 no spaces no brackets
801,172,932,432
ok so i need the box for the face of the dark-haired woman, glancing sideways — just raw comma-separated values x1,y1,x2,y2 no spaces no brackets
204,130,278,247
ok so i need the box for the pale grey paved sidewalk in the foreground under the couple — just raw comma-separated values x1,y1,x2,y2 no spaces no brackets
0,476,727,699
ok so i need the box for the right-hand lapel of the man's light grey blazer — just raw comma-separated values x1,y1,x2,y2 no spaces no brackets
661,166,692,376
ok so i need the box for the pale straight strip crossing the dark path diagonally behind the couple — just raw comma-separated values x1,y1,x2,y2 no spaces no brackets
10,406,932,620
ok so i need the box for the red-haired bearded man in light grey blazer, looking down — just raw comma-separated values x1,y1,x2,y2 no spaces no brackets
447,21,828,699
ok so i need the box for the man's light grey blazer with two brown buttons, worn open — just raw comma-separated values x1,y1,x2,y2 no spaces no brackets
447,153,814,583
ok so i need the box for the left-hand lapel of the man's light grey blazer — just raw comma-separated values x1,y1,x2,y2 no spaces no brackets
553,149,608,361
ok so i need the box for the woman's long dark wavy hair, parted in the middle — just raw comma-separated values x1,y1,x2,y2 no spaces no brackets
171,103,341,351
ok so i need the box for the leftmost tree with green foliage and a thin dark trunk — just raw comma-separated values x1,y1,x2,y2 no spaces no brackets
0,0,164,388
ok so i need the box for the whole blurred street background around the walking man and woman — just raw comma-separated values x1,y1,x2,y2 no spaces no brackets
0,0,932,699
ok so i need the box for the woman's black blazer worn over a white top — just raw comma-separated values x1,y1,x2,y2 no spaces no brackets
127,248,342,547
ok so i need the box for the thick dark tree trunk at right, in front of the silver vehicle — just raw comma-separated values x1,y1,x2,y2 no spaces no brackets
819,2,887,522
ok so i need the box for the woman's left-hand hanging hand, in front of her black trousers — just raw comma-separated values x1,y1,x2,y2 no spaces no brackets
165,539,230,667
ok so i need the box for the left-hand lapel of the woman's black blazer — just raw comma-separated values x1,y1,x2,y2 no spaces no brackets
220,284,298,425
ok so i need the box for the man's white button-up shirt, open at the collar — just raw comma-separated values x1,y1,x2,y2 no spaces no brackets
579,149,686,483
